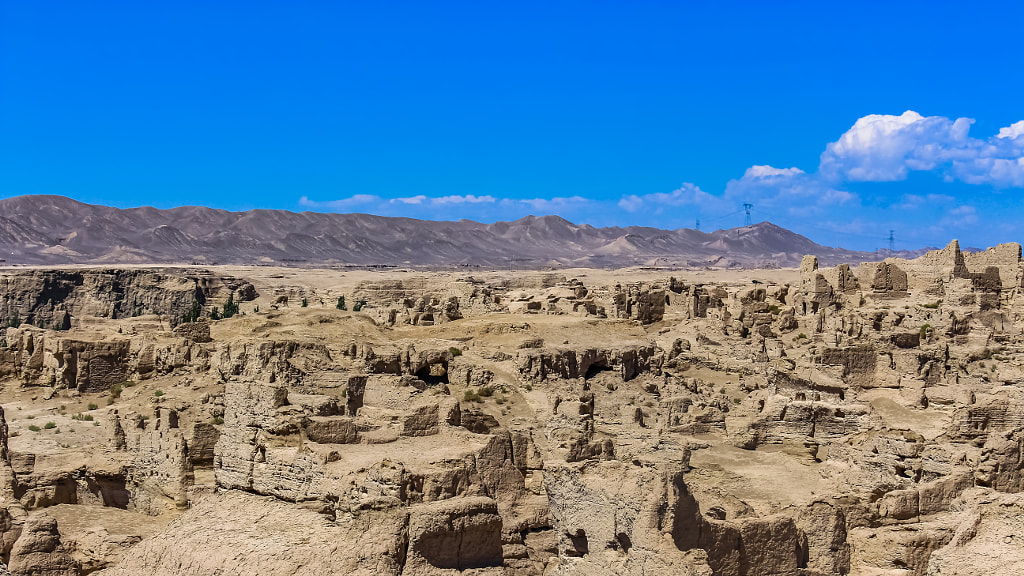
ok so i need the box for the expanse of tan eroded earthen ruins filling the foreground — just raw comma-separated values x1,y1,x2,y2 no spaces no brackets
0,244,1024,576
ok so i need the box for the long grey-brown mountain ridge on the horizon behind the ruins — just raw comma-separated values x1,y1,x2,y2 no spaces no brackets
0,196,914,269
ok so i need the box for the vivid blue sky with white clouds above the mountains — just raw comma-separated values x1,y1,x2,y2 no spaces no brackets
0,0,1024,250
